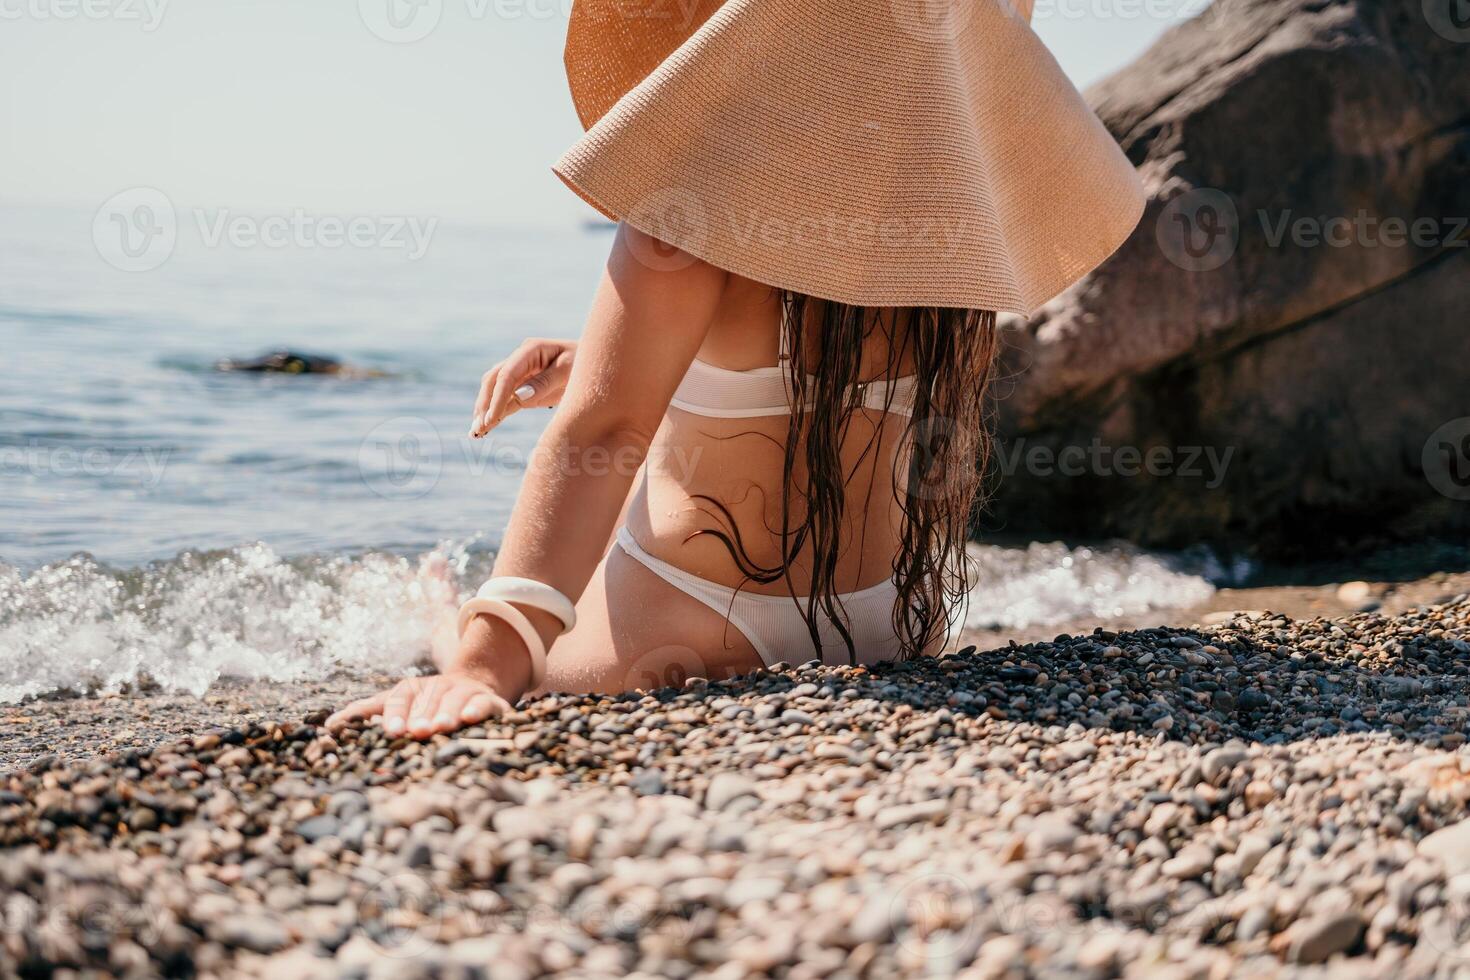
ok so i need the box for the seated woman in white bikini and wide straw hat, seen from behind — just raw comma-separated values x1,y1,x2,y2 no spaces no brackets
332,0,1142,738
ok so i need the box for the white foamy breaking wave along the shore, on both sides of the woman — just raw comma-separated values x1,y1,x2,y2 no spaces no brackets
0,539,1229,704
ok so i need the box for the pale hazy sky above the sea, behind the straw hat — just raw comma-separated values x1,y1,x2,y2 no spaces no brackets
0,0,1202,223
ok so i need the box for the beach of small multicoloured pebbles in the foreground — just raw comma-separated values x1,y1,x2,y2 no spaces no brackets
0,595,1470,980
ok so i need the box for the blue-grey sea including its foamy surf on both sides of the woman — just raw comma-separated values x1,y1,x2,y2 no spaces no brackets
0,207,1217,702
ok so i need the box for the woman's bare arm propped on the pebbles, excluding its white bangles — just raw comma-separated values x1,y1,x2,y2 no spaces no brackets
328,225,726,738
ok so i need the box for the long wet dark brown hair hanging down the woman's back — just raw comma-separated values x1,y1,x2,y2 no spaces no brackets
687,292,997,661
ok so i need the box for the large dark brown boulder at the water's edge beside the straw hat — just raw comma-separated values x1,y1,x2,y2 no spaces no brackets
988,0,1470,554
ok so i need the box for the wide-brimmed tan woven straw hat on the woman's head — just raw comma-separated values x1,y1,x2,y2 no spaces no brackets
554,0,1144,314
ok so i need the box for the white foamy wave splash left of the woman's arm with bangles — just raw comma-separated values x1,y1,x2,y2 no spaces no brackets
0,545,485,704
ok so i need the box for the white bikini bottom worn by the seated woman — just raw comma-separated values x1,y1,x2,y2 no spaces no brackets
617,526,900,667
